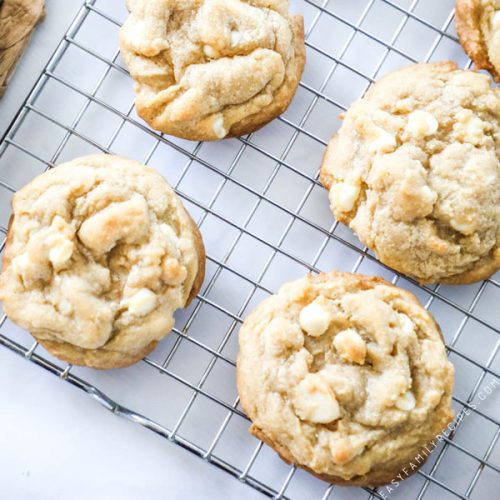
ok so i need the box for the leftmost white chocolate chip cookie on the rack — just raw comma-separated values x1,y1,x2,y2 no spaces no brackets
0,155,205,369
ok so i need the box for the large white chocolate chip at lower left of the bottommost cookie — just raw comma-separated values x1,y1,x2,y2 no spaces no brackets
293,373,341,424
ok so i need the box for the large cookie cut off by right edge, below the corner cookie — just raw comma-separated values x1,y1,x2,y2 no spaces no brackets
321,62,500,284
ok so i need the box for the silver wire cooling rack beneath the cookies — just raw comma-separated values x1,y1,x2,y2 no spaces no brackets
0,0,500,499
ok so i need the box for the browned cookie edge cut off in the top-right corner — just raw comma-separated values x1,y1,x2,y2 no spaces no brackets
455,0,500,82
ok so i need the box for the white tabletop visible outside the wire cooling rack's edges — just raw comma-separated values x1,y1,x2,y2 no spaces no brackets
0,0,260,500
